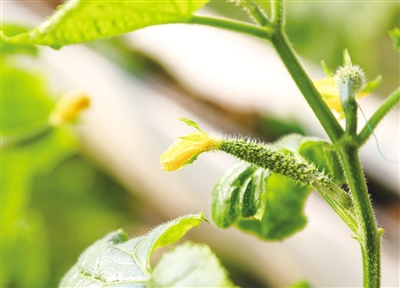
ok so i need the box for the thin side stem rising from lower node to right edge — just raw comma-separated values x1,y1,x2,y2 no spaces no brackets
357,88,400,147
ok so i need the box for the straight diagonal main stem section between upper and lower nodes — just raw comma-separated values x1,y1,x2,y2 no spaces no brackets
271,31,344,143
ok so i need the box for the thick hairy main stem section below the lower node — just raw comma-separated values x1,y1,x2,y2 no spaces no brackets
338,146,381,288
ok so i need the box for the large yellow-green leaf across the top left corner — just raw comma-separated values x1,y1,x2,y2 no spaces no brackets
2,0,208,49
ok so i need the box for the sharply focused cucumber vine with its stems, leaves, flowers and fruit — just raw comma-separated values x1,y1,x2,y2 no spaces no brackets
2,0,400,287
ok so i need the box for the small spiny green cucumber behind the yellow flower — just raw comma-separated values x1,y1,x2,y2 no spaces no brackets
219,139,330,186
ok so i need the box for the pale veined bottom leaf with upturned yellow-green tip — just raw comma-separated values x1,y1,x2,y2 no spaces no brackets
60,213,205,287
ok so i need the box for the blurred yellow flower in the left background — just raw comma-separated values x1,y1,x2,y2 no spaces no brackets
49,92,90,126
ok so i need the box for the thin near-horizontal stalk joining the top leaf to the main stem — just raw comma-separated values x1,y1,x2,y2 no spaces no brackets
189,15,274,39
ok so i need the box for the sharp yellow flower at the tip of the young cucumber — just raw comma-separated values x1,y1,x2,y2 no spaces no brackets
160,118,222,171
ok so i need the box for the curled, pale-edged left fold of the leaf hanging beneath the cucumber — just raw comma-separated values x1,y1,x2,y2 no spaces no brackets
211,162,270,228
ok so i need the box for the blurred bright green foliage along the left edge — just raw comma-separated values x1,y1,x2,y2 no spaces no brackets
0,25,141,287
